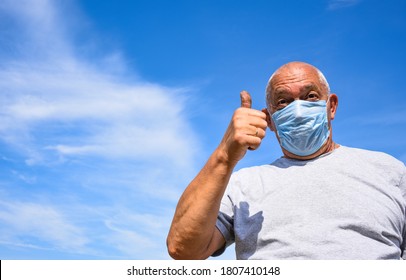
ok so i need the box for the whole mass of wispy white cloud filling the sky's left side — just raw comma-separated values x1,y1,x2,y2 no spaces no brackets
0,0,198,258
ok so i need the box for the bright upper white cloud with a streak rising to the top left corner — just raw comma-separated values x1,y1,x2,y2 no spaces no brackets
0,0,196,166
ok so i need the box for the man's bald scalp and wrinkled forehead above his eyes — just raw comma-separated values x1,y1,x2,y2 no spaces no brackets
266,61,330,109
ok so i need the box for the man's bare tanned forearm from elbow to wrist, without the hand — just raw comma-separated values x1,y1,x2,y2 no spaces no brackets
167,149,235,259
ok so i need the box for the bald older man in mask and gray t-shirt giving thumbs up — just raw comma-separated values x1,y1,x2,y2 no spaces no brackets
167,62,406,259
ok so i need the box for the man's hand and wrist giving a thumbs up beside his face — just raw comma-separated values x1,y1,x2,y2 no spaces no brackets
218,91,267,164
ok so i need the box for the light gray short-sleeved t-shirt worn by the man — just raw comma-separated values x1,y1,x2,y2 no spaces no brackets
216,146,406,259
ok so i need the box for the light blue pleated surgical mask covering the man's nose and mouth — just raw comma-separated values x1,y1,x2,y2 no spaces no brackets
272,100,330,156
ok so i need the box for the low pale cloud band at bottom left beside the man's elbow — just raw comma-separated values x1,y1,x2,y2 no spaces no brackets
0,192,171,259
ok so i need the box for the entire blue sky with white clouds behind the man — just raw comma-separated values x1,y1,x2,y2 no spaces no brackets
0,0,406,259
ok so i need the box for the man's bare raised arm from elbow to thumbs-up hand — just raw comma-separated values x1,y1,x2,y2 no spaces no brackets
167,91,267,259
